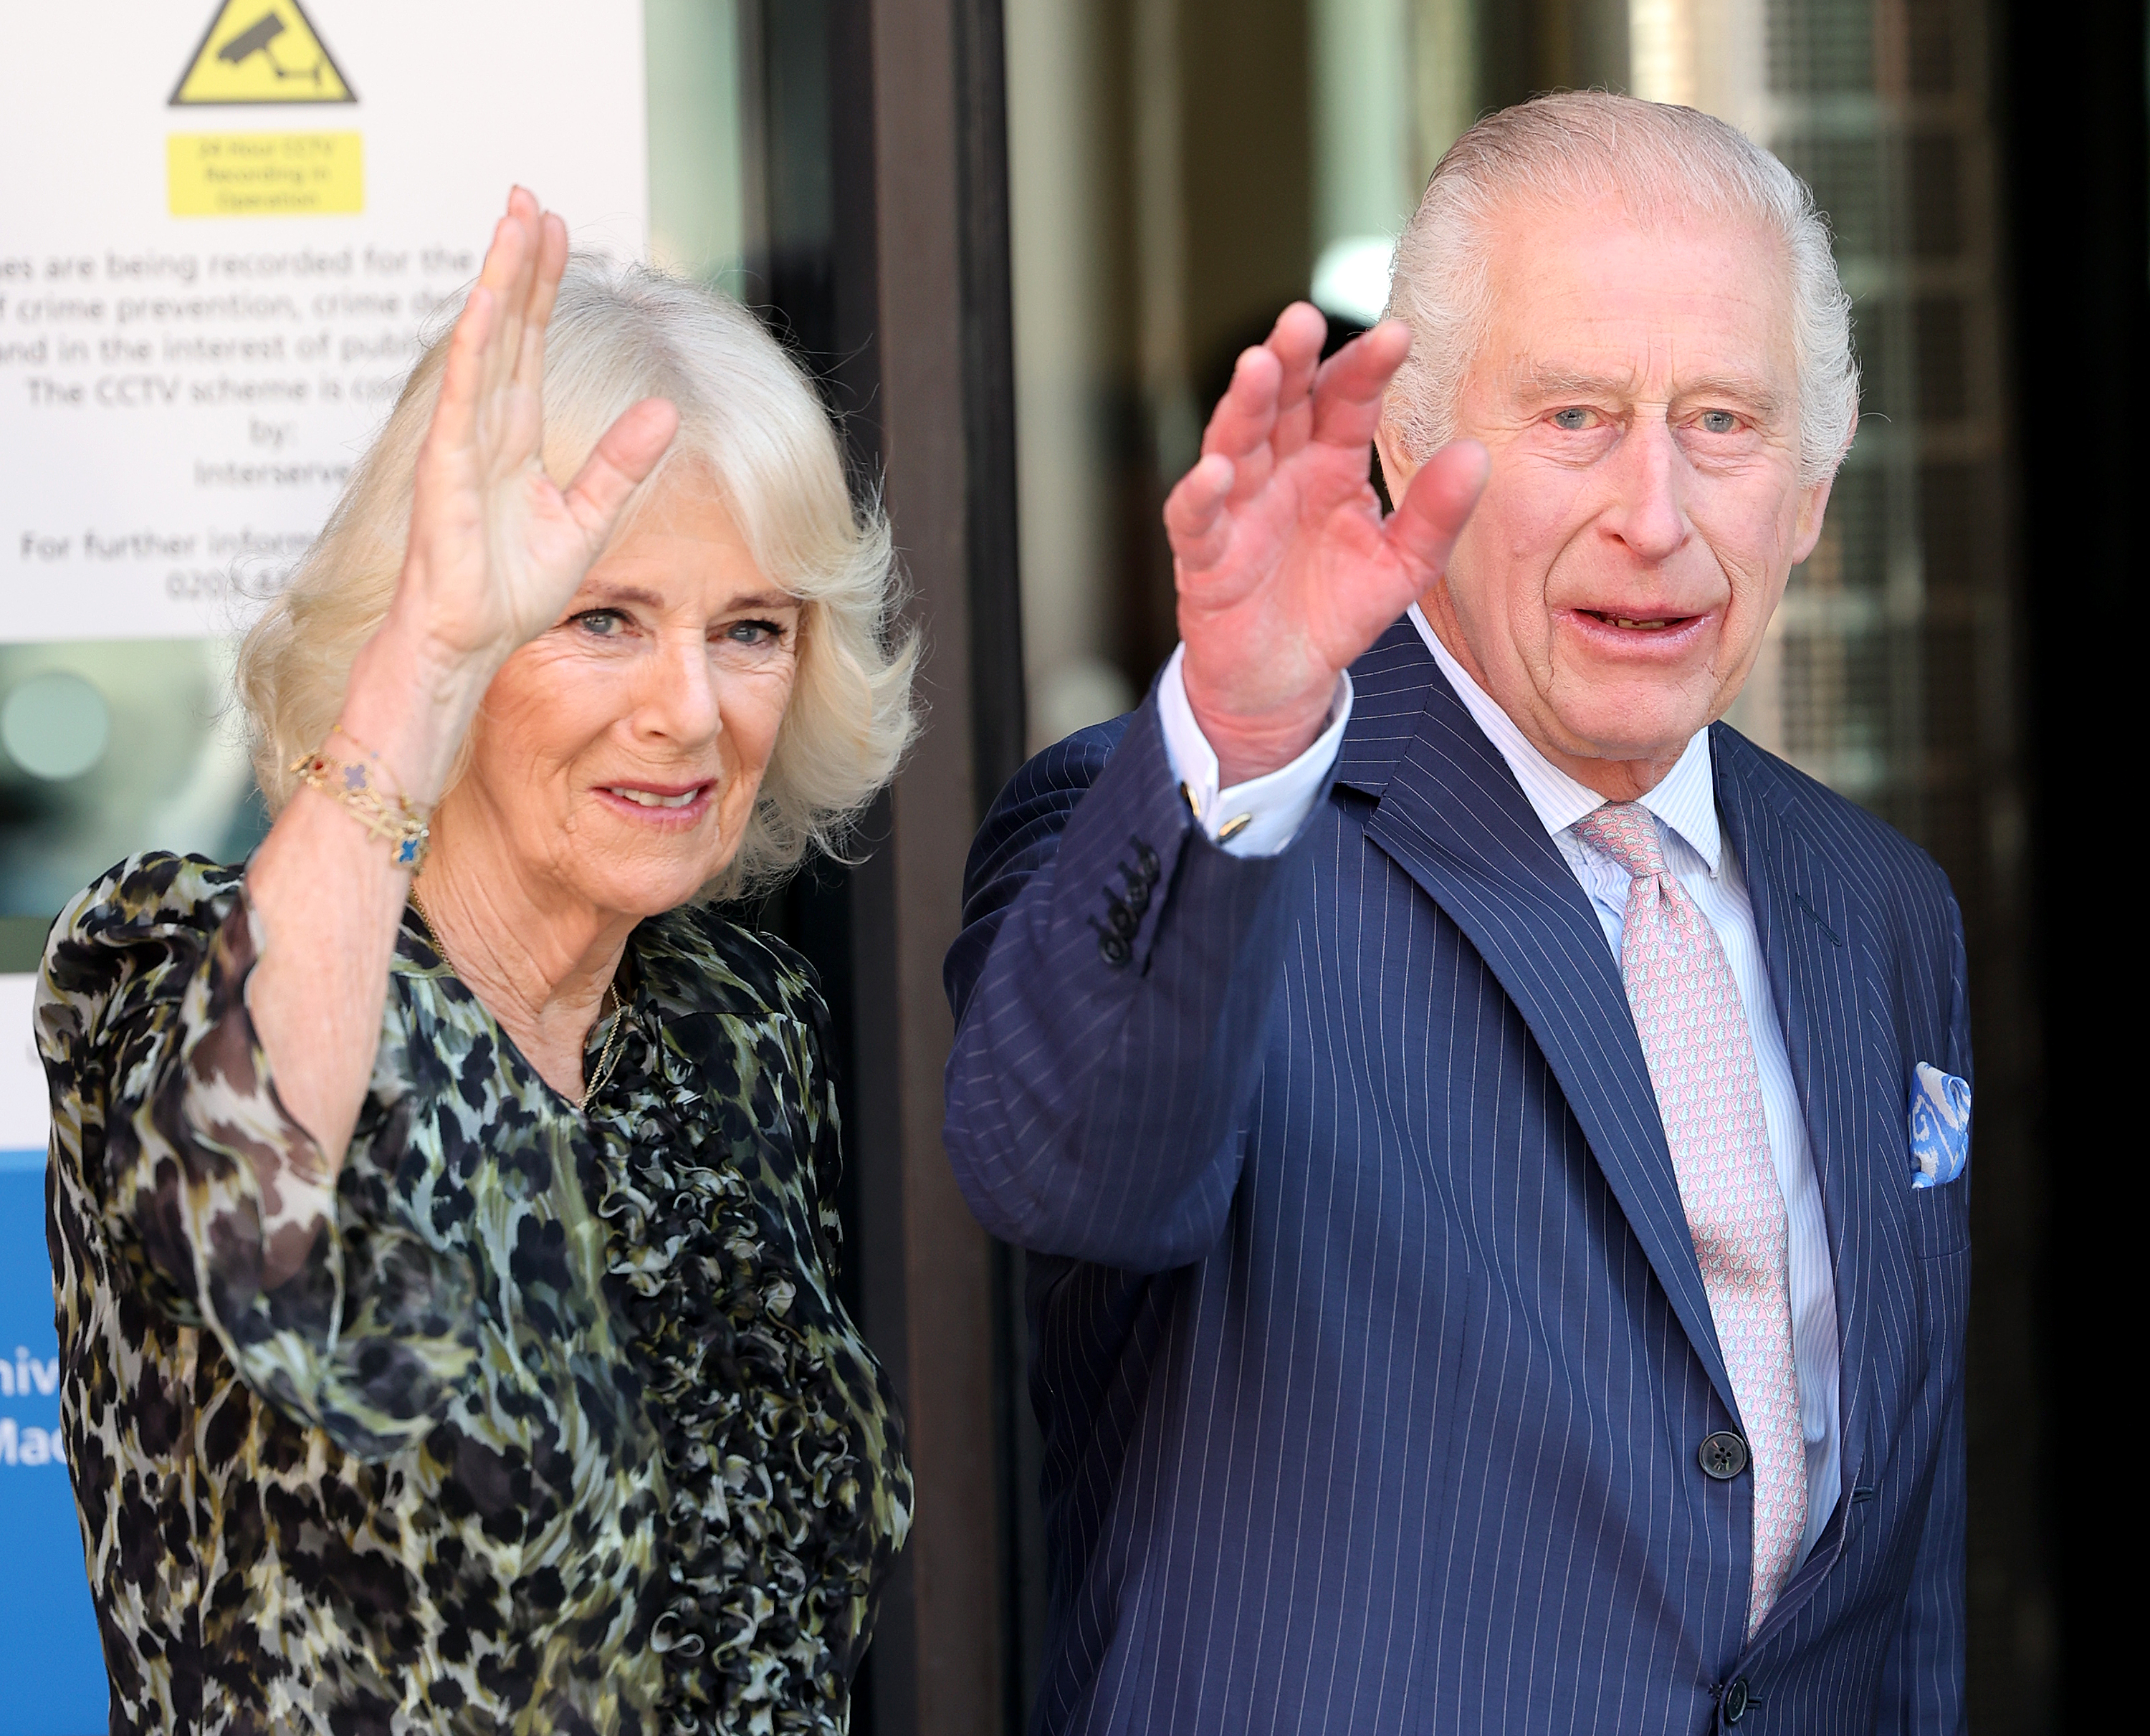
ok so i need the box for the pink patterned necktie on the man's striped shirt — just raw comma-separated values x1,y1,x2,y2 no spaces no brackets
1576,802,1806,1635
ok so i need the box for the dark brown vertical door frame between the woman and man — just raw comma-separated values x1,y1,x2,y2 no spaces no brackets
752,0,1026,1736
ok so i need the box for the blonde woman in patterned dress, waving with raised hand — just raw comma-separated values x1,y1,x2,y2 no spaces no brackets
37,191,912,1734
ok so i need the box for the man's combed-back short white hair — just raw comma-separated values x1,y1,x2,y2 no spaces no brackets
1385,90,1860,484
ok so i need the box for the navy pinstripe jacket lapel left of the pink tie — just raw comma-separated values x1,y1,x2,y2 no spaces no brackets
1337,621,1737,1416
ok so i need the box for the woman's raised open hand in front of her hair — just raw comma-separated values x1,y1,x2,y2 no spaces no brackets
396,187,679,666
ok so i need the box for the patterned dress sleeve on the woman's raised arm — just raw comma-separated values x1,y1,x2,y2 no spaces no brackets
37,853,479,1459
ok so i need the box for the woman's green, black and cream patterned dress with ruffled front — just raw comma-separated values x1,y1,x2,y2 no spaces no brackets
37,855,912,1736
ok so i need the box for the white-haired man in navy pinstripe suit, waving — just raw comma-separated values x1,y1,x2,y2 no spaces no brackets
948,95,1969,1736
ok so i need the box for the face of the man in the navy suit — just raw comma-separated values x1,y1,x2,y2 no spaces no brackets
1382,200,1830,795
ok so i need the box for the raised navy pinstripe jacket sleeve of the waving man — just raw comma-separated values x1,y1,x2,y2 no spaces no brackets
946,694,1307,1272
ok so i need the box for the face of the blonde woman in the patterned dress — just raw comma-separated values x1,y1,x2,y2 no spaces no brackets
445,469,800,917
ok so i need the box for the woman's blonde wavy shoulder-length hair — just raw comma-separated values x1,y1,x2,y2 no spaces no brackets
236,254,918,898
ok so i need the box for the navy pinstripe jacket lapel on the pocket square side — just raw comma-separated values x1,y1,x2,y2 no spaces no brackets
1711,724,1907,1538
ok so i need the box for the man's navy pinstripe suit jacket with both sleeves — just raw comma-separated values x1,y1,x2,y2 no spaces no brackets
948,623,1972,1736
